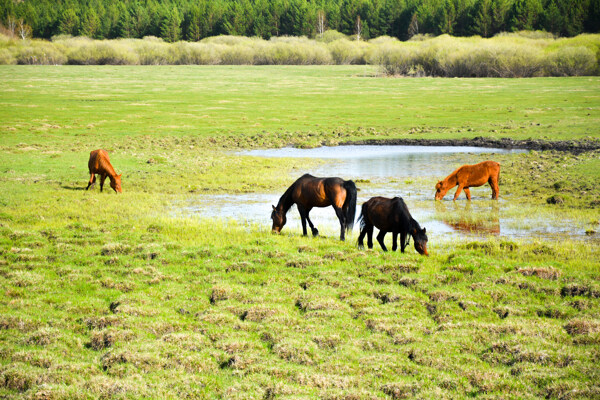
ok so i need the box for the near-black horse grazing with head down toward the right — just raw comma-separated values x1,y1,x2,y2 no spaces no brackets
358,197,429,256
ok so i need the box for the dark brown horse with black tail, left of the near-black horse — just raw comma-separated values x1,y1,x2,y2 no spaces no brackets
271,174,357,240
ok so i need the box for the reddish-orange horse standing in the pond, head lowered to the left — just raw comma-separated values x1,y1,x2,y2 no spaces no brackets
435,161,500,200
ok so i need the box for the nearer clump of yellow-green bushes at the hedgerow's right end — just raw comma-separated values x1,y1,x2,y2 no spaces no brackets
368,35,600,78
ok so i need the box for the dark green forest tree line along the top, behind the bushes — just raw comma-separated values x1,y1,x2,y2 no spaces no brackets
0,0,600,42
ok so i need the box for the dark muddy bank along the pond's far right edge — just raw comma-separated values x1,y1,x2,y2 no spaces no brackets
340,137,600,154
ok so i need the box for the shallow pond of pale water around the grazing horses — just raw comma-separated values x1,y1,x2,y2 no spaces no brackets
177,146,586,241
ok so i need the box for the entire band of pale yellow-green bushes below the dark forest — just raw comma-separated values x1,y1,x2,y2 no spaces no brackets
0,31,600,78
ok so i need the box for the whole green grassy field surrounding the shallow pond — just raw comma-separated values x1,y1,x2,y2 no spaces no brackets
0,66,600,399
